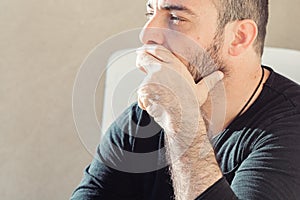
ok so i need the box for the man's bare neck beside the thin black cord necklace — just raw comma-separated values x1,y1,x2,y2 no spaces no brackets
202,61,269,138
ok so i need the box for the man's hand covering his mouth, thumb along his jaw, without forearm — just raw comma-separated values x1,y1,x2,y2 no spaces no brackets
137,45,223,137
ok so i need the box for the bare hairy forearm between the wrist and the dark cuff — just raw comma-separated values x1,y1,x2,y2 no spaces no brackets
166,120,222,200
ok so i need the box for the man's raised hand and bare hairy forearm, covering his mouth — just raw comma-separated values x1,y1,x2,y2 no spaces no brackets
137,45,223,200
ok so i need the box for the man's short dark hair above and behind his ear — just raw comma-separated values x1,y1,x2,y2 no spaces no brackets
214,0,269,56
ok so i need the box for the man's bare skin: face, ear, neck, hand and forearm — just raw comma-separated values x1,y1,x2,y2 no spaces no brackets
137,0,269,200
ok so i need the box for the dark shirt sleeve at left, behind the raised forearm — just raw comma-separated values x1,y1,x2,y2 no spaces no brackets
71,104,161,200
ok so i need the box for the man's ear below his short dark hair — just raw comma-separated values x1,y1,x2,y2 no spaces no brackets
229,19,258,56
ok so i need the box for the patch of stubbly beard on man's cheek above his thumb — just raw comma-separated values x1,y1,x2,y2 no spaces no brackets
187,33,225,83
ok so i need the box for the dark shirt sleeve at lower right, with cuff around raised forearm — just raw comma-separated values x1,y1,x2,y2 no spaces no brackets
197,114,300,200
